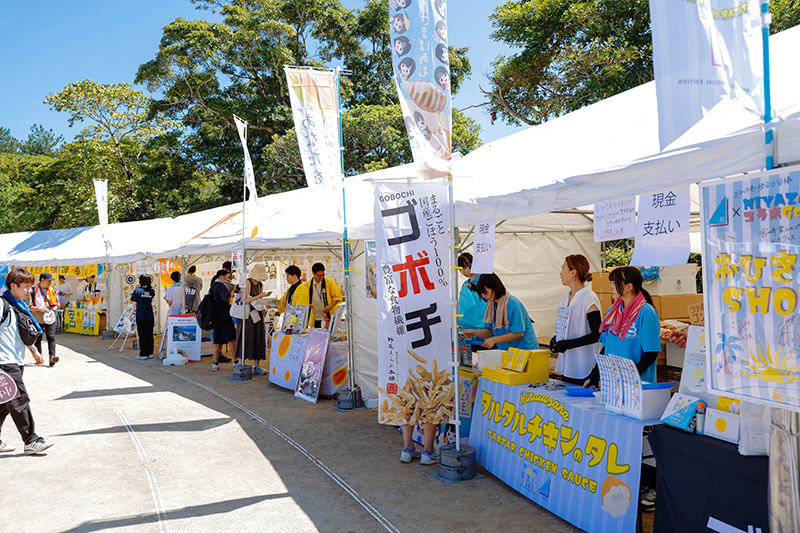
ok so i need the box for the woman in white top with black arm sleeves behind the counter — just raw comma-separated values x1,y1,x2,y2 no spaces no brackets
550,254,603,385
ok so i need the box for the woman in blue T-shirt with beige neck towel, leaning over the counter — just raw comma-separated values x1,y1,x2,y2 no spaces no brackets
464,274,539,350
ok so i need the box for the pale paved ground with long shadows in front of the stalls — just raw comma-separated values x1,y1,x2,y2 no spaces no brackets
0,334,608,533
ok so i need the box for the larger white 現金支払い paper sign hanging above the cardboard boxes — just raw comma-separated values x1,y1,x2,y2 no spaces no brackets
631,187,690,266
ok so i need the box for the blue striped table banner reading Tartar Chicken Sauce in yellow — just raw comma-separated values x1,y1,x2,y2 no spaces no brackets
469,378,653,533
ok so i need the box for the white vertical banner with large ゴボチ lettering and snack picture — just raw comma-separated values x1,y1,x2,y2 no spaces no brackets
375,181,454,426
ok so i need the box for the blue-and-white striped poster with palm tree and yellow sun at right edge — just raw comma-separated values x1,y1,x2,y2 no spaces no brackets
701,171,800,411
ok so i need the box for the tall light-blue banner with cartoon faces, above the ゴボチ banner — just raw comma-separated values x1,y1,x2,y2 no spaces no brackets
389,0,452,168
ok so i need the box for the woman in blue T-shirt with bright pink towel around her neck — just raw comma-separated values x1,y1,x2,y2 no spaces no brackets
590,266,661,383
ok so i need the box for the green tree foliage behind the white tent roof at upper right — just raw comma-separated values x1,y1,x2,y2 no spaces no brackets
484,0,800,125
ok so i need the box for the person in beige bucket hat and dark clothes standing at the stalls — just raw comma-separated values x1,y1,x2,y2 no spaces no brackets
236,263,271,376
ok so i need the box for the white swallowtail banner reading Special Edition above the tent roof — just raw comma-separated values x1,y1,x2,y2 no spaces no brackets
650,0,764,150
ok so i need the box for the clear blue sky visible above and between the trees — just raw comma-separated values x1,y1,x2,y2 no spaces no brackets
0,0,518,142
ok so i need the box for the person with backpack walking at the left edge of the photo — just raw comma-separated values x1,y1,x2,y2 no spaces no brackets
0,268,53,455
